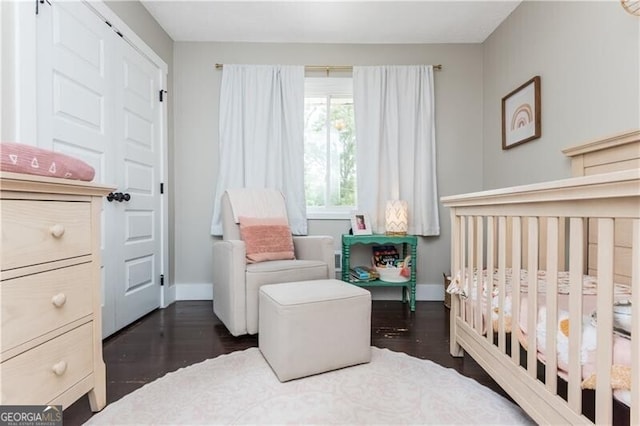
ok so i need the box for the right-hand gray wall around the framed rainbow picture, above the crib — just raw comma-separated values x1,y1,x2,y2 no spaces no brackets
482,1,640,189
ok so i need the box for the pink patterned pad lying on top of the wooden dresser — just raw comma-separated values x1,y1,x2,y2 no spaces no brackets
0,142,95,181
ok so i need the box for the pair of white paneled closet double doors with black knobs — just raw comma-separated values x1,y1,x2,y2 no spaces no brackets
37,1,162,338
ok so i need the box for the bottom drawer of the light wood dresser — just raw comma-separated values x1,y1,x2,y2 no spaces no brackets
0,322,93,405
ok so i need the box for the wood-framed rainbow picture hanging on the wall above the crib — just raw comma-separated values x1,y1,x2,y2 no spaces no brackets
502,75,542,150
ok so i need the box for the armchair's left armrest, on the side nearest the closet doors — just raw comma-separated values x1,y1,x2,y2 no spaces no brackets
213,240,247,336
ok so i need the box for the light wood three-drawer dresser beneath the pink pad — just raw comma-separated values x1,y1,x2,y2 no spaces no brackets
0,172,112,411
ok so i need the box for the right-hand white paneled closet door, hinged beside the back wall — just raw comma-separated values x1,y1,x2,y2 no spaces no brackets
114,37,162,329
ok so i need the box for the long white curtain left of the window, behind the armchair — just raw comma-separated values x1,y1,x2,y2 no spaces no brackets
211,64,307,235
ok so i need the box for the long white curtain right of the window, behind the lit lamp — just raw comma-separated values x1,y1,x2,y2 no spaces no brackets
353,65,440,235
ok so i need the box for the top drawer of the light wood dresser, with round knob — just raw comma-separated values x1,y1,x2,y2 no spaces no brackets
0,200,91,271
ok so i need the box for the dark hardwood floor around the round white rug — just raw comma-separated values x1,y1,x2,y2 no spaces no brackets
64,301,506,426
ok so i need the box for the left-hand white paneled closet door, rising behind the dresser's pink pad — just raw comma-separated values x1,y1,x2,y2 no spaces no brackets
37,2,117,179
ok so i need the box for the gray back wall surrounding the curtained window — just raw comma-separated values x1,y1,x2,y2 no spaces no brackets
174,42,482,297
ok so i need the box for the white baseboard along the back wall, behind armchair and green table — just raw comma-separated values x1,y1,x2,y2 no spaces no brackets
173,283,444,301
